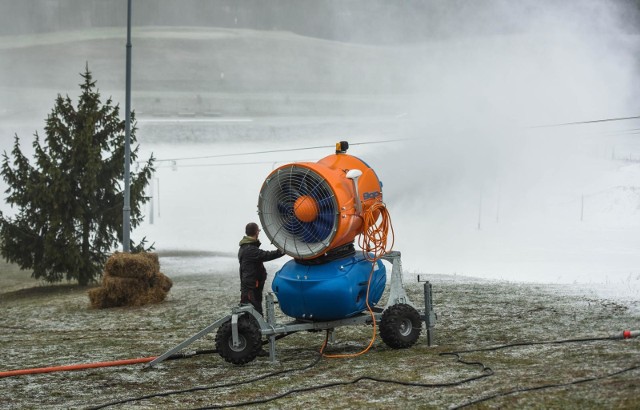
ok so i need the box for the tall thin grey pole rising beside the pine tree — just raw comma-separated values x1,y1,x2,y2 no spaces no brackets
122,0,131,252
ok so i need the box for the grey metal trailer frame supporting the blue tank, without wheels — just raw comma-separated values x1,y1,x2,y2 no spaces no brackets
145,251,436,368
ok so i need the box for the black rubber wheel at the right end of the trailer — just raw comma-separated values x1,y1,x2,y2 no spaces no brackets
380,303,422,349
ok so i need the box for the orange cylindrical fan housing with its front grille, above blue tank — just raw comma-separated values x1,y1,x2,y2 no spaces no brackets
258,152,382,259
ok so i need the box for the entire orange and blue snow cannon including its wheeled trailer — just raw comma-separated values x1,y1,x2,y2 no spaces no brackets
148,141,436,367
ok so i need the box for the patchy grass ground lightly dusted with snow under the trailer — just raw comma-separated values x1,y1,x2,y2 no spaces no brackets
0,255,640,409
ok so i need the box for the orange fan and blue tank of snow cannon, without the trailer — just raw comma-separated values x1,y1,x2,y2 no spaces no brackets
258,141,386,321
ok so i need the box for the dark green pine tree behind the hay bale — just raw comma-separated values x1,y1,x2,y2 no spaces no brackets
0,66,154,285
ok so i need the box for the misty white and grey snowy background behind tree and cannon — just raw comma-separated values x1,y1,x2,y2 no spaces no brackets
0,0,640,298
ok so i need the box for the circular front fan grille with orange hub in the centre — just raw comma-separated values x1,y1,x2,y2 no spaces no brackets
258,165,339,259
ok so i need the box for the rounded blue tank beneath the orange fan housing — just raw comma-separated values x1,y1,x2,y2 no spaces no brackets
271,252,387,321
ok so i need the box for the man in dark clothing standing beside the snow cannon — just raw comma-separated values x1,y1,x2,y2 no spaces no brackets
238,222,284,315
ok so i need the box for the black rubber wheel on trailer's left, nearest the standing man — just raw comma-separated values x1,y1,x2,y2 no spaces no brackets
216,314,262,364
